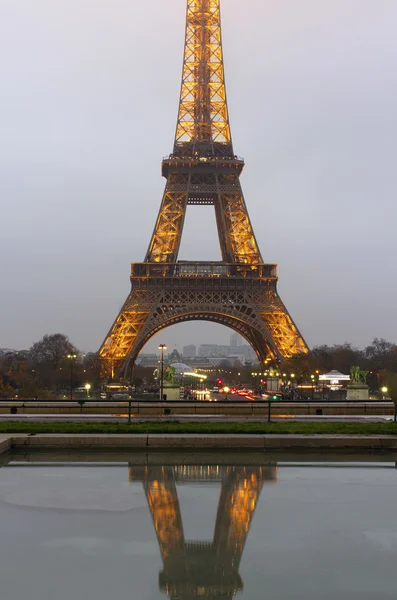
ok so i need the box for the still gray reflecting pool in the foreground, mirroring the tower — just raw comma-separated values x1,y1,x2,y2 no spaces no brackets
0,453,397,600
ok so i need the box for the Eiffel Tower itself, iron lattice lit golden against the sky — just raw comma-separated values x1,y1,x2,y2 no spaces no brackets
99,0,308,378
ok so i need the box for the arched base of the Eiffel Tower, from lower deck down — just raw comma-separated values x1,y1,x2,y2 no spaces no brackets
100,262,307,379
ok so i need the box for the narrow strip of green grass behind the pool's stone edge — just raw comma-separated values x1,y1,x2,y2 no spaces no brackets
0,421,397,436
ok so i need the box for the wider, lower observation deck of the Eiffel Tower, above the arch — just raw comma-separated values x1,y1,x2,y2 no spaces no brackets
131,261,278,281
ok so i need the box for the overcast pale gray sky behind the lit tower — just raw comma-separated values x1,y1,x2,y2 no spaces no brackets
0,0,397,350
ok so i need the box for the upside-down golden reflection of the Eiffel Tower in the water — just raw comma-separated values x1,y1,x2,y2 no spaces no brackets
129,465,277,600
